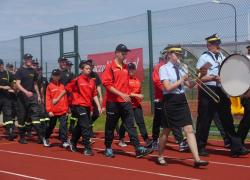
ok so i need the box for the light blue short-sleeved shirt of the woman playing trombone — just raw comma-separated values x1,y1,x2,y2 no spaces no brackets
159,61,185,94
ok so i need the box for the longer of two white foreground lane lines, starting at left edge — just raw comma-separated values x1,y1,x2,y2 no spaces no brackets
0,149,199,180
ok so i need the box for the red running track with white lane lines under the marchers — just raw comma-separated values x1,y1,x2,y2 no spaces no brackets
0,130,250,180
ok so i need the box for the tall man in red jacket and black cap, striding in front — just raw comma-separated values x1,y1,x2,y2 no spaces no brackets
102,44,152,157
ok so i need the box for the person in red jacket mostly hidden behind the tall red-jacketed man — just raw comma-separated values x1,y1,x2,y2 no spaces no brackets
119,63,152,147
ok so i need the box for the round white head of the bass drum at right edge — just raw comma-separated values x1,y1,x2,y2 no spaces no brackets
219,54,250,96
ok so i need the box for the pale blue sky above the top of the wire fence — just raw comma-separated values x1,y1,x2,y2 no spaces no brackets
0,0,209,41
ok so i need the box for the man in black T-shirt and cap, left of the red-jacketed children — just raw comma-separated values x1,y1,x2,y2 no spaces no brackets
16,54,46,145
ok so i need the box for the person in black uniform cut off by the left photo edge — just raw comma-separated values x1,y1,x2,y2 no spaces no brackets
0,59,14,141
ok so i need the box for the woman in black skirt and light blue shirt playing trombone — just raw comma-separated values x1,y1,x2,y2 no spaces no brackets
157,46,208,167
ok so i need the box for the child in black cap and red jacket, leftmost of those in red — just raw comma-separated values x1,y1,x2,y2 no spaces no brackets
45,69,69,148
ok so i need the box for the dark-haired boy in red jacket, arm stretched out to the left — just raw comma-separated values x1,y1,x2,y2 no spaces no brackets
54,61,101,156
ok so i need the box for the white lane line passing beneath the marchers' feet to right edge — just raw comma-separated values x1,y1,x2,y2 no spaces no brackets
90,138,250,168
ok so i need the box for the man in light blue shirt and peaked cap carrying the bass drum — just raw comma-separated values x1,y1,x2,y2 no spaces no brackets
196,34,249,157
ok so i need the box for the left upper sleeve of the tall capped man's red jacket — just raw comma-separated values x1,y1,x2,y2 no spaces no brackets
102,64,114,90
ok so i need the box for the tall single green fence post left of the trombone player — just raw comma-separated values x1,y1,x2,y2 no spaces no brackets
147,10,154,113
